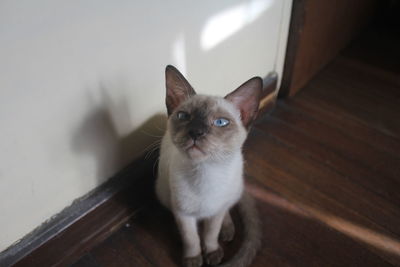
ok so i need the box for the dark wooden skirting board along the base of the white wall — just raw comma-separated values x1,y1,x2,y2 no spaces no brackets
0,74,277,266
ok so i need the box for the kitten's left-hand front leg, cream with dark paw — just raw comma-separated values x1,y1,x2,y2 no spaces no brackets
175,214,203,267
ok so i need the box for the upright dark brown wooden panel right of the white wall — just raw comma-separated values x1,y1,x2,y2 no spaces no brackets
280,0,377,96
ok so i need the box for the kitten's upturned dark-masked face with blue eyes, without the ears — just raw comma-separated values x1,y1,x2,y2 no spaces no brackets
168,95,247,160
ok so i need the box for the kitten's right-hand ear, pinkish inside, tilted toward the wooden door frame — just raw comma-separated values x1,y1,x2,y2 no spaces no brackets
225,77,263,128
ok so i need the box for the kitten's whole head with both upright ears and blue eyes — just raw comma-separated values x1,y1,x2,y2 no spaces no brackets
165,66,262,161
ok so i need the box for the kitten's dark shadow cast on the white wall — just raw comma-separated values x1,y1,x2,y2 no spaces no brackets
71,87,167,183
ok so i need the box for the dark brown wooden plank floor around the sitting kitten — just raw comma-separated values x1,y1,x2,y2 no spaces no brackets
74,28,400,267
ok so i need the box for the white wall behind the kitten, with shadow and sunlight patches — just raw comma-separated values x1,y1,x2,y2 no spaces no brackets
0,0,291,251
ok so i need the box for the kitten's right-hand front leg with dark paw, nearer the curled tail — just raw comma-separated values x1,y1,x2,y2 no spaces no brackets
204,211,226,265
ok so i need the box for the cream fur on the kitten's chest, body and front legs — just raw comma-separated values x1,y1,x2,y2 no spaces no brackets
156,98,246,257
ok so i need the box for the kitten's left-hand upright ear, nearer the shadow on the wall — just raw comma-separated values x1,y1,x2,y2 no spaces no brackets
165,65,196,116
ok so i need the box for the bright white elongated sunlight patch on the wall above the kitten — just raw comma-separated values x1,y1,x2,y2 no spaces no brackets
200,0,272,51
